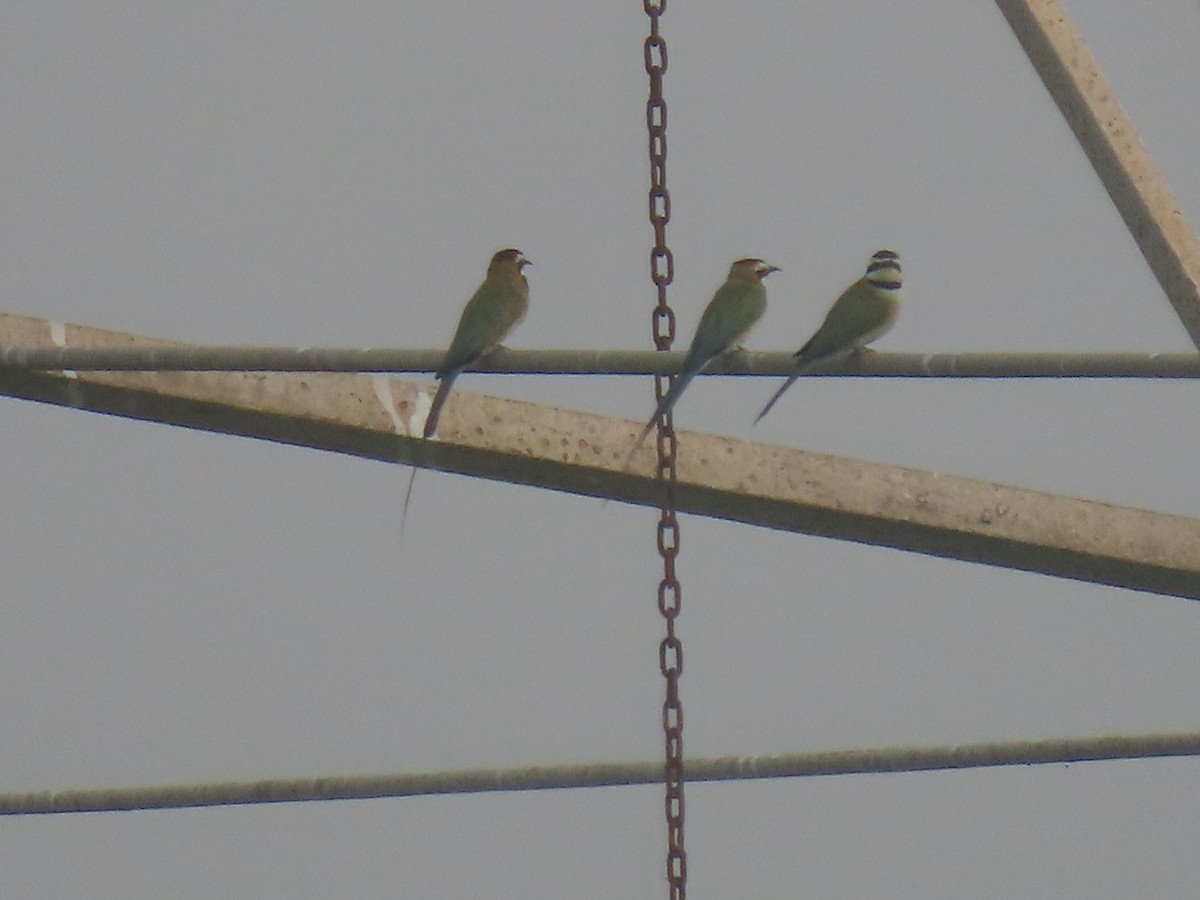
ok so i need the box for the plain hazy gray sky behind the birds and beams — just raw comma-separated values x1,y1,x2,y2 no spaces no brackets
0,0,1200,898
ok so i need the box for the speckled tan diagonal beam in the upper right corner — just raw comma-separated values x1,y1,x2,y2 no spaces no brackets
996,0,1200,348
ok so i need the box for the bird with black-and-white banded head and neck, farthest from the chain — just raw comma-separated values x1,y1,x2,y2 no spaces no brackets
754,250,904,425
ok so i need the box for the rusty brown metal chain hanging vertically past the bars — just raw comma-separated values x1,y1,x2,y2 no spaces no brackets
642,0,688,900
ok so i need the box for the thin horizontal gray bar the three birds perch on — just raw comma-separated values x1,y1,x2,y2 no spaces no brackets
0,346,1200,378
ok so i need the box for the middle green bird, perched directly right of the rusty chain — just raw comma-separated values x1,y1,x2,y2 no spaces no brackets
625,258,782,466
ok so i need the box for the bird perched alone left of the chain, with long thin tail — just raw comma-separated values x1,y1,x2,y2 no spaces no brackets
400,247,533,539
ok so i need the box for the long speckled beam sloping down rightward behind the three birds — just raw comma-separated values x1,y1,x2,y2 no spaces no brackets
7,314,1200,599
